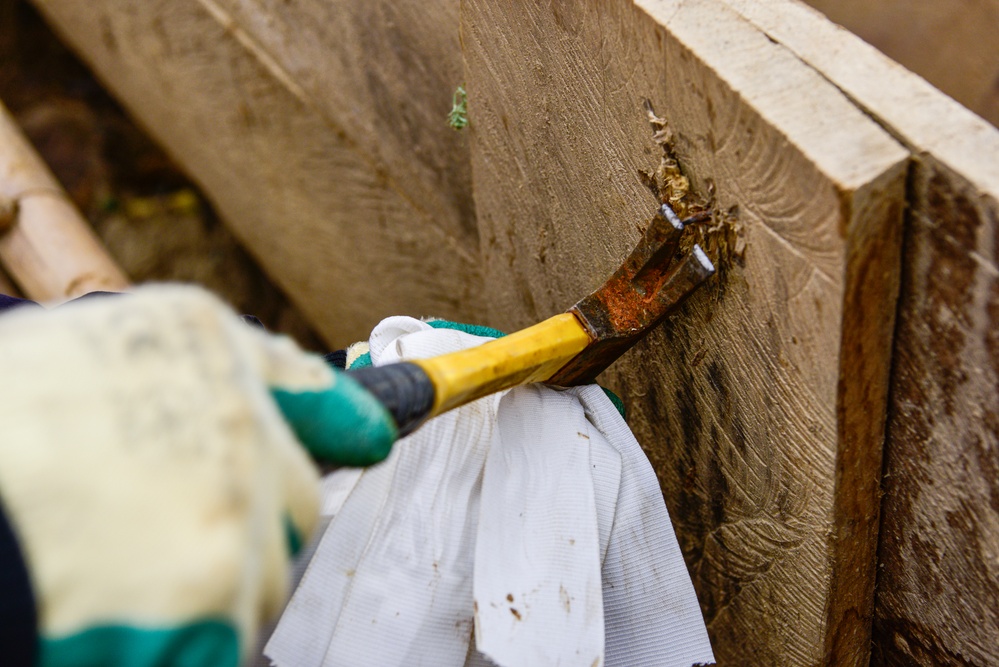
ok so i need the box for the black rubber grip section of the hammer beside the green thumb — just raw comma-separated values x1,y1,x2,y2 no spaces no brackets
347,362,434,438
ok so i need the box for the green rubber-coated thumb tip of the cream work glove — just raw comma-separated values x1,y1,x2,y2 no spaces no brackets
271,371,398,466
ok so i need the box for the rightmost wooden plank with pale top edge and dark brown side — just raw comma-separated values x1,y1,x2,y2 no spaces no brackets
716,0,999,665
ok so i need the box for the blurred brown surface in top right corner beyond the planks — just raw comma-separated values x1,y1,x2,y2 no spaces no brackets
806,0,999,125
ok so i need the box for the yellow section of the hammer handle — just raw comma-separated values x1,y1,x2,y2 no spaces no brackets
412,313,591,417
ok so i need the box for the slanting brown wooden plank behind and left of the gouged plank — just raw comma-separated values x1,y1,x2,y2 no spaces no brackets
37,0,482,345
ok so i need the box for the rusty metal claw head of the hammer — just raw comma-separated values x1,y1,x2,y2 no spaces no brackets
548,204,715,387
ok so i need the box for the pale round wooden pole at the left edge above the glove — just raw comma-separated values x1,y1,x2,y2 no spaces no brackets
0,103,129,302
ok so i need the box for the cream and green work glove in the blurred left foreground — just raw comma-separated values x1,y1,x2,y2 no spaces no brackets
0,286,395,667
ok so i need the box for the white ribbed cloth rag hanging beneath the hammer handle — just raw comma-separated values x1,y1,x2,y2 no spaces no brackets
265,317,714,667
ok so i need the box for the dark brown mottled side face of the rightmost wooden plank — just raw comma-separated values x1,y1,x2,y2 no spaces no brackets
874,162,999,665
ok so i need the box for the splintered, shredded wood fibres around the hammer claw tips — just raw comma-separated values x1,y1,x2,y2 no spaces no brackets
638,100,746,288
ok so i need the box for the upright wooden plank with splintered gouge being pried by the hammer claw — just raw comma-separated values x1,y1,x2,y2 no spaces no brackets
462,0,907,665
